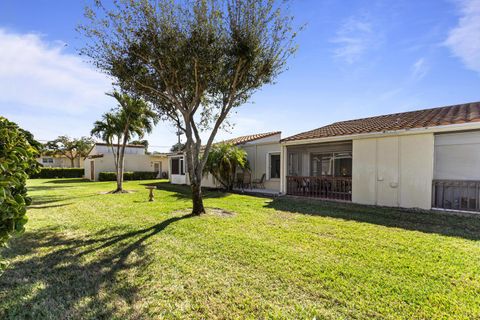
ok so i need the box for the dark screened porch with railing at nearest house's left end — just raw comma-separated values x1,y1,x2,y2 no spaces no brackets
286,141,352,201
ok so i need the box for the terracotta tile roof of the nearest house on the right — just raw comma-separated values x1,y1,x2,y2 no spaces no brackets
282,102,480,141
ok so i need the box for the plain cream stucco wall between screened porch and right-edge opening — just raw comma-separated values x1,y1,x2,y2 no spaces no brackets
352,133,434,209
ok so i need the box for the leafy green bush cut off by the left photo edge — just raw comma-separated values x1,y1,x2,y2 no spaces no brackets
0,117,38,246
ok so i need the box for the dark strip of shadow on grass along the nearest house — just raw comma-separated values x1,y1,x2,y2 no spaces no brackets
266,197,480,240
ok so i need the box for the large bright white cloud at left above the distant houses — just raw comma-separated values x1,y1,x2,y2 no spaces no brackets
0,29,111,115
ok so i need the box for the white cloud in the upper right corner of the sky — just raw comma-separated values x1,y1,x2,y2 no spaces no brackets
445,0,480,72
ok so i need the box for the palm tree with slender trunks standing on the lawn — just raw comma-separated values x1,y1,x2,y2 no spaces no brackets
91,91,158,193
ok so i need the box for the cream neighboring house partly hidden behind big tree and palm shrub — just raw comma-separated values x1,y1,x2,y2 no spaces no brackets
169,132,281,192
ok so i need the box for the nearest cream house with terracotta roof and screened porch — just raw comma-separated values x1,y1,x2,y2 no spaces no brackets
280,102,480,211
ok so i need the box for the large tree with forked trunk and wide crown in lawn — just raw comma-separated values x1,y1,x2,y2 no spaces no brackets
79,0,296,214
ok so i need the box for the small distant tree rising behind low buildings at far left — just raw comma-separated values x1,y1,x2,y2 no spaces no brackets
45,136,94,168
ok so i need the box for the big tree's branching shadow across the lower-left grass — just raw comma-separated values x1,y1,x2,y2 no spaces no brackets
0,215,192,319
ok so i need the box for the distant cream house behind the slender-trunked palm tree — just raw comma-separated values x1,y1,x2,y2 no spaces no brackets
85,143,169,181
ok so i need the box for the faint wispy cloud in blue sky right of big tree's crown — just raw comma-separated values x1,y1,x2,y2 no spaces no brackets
331,18,375,64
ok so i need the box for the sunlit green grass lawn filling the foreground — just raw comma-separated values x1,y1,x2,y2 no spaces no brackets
0,179,480,319
